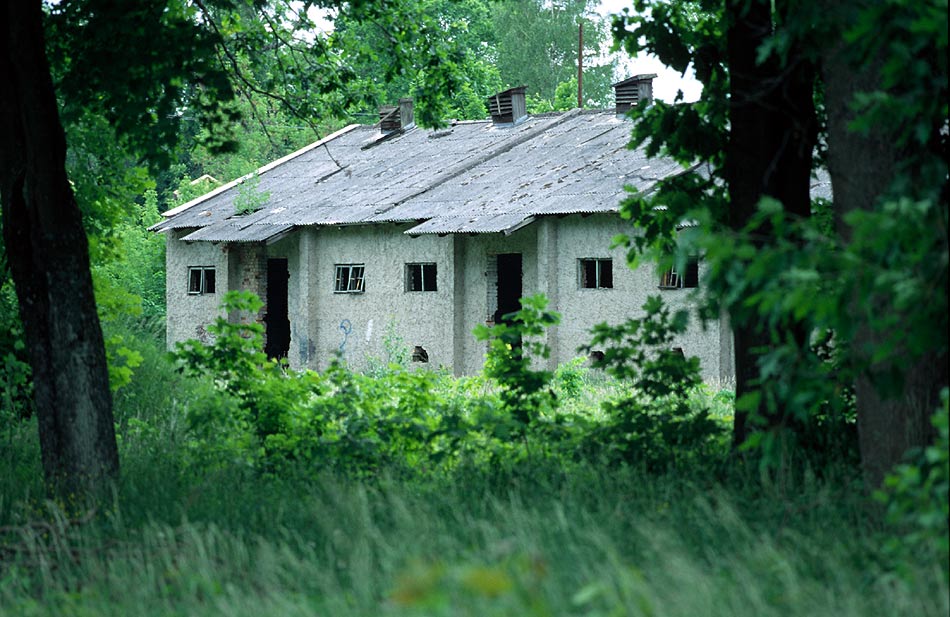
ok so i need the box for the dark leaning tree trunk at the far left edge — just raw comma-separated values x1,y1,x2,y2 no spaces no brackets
0,0,119,495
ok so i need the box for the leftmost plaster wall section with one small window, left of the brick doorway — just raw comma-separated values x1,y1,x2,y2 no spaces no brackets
165,229,228,349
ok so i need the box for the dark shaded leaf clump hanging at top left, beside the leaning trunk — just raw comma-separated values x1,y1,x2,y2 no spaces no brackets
45,0,242,165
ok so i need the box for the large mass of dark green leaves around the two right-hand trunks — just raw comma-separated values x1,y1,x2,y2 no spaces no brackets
613,0,948,472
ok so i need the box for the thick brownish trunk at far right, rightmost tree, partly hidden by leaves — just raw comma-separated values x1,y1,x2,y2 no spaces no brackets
822,39,947,488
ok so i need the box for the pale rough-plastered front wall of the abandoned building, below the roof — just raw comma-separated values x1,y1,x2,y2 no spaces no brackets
168,214,733,380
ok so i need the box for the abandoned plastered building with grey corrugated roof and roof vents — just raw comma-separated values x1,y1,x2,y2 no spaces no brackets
152,75,733,379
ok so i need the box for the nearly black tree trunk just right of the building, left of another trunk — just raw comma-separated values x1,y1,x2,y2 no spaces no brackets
726,0,817,446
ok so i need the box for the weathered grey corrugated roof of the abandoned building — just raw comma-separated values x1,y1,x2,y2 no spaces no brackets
152,110,840,242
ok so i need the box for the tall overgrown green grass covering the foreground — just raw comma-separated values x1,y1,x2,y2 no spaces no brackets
0,320,950,617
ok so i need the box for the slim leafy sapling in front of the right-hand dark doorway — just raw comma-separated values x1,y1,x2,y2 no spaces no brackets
474,294,561,435
